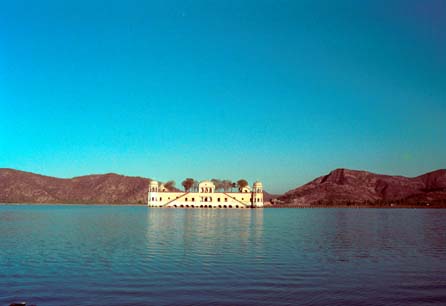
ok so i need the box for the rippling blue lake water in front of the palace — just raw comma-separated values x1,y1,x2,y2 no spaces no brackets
0,205,446,306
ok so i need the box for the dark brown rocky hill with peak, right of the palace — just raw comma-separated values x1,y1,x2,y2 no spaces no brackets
278,169,446,205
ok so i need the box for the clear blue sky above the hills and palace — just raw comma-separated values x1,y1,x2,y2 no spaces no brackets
0,0,446,192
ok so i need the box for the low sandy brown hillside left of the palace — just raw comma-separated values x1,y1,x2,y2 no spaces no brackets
0,169,149,204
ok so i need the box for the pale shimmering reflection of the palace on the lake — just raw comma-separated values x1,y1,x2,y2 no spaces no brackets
146,209,263,255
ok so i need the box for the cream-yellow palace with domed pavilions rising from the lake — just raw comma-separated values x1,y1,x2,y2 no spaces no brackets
148,181,263,208
